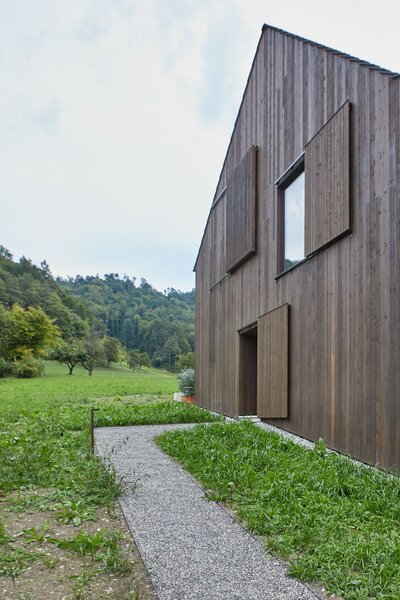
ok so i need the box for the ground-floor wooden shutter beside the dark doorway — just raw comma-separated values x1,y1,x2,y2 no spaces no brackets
257,304,289,419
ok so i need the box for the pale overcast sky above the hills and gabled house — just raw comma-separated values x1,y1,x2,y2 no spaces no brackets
0,0,400,290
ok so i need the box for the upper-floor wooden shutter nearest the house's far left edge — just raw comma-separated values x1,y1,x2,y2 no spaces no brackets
226,146,257,273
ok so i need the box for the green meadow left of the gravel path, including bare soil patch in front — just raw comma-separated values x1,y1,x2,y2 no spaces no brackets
0,362,219,600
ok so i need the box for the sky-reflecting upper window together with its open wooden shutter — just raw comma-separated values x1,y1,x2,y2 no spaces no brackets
275,101,351,278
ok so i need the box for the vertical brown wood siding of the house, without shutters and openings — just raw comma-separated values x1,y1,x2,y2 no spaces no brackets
196,28,400,468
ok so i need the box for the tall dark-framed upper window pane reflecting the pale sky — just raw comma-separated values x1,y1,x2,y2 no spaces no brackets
277,155,305,273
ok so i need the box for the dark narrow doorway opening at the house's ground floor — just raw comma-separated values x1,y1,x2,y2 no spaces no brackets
239,326,257,416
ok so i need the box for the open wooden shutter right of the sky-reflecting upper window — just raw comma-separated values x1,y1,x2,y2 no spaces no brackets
304,102,350,256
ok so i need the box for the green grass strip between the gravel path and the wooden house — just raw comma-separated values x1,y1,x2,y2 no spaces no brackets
157,422,400,600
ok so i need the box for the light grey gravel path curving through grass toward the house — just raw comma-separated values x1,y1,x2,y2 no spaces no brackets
96,425,317,600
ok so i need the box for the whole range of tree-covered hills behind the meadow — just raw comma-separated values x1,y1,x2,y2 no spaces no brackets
0,246,195,368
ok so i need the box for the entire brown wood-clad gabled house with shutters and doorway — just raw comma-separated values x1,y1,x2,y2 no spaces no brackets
195,25,400,469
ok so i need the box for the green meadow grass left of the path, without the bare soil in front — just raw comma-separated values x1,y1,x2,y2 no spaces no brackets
0,363,219,492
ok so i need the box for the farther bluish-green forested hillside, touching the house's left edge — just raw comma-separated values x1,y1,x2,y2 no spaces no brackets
57,273,195,368
